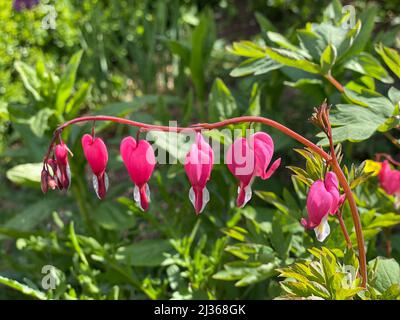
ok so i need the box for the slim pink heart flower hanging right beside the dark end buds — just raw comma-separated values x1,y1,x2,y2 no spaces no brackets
82,134,108,199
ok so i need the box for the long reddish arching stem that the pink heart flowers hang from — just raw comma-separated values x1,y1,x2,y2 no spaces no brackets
44,115,367,288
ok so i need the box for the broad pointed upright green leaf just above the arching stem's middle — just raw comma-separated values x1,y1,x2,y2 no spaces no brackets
209,78,237,120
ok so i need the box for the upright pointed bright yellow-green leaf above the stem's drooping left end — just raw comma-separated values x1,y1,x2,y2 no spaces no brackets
56,50,83,115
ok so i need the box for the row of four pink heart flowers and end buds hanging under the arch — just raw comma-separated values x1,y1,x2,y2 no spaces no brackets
42,132,281,214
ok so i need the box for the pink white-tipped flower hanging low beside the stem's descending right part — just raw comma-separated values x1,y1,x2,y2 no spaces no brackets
301,172,345,242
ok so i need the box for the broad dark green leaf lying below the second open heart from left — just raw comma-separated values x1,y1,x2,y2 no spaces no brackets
115,239,172,267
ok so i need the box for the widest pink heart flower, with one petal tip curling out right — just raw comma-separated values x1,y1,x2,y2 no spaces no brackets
226,132,281,208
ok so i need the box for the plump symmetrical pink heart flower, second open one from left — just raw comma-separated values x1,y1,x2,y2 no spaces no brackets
120,137,156,211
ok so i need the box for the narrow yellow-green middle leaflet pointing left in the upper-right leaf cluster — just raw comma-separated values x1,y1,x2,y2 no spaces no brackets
265,47,320,73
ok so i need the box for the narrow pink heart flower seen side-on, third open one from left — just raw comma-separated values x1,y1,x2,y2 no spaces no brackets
185,132,214,214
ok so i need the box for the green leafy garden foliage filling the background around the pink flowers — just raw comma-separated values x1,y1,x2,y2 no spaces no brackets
0,0,400,299
